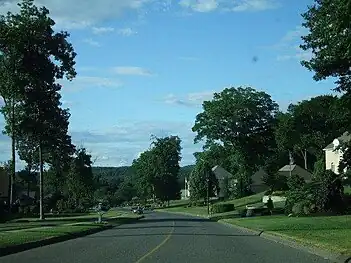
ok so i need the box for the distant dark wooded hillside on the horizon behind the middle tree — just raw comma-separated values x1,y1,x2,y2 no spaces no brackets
93,165,194,189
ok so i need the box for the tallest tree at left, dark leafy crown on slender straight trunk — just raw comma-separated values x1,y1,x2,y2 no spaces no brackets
0,0,76,218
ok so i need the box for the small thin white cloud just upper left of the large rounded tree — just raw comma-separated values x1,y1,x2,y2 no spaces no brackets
164,91,215,107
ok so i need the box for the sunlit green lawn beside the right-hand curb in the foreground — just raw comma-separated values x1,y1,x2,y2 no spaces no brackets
223,216,351,255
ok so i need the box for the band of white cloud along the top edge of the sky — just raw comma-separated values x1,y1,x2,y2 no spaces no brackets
0,0,280,31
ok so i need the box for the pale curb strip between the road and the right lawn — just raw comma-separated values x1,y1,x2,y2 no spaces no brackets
218,220,351,263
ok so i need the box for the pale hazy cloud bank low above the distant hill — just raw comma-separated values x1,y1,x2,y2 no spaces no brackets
70,120,202,166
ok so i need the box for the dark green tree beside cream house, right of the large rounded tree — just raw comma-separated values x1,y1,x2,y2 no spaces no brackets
275,95,348,170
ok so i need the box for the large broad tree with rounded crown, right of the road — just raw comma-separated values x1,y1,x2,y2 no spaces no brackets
192,87,278,176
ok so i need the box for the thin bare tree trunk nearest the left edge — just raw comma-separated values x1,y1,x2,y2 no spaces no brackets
9,100,16,211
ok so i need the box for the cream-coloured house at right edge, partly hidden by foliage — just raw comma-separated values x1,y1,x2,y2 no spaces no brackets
323,132,351,174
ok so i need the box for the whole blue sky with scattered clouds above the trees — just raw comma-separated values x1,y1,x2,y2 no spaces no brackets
0,0,333,169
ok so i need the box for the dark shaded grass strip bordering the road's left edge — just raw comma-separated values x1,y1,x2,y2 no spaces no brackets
0,216,144,257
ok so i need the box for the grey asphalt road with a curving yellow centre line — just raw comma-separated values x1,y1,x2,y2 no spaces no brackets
0,212,336,263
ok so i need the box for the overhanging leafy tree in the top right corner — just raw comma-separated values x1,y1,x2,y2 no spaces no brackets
301,0,351,171
